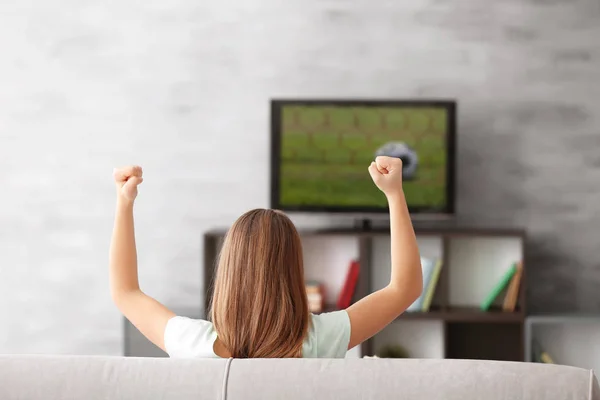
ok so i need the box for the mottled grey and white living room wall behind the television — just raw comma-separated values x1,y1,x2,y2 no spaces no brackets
0,0,600,354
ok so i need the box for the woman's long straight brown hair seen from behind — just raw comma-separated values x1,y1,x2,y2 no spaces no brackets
211,209,309,358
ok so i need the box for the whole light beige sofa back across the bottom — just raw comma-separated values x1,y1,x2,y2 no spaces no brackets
0,356,600,400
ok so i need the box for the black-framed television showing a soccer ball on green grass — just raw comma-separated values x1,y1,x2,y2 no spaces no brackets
271,99,456,214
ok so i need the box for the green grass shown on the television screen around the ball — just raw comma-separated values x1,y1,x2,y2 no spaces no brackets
280,106,447,208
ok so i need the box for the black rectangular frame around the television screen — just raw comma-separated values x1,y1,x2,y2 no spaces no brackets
270,98,457,215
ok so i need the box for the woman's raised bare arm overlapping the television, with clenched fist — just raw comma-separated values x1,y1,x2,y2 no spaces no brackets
347,157,423,349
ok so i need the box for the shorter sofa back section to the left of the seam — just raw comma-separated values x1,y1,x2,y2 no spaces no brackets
0,356,228,400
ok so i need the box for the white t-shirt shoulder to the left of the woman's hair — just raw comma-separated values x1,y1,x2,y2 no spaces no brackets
165,316,217,358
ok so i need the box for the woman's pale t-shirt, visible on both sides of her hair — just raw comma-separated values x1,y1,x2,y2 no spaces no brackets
165,310,350,358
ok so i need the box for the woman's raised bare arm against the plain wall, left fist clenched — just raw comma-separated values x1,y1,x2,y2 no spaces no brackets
109,166,175,351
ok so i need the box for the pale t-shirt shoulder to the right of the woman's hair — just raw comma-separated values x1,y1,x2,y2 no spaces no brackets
303,310,350,358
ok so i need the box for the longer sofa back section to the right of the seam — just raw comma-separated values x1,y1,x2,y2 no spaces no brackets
227,359,598,400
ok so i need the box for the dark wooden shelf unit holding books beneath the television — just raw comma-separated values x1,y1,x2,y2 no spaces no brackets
203,221,526,361
